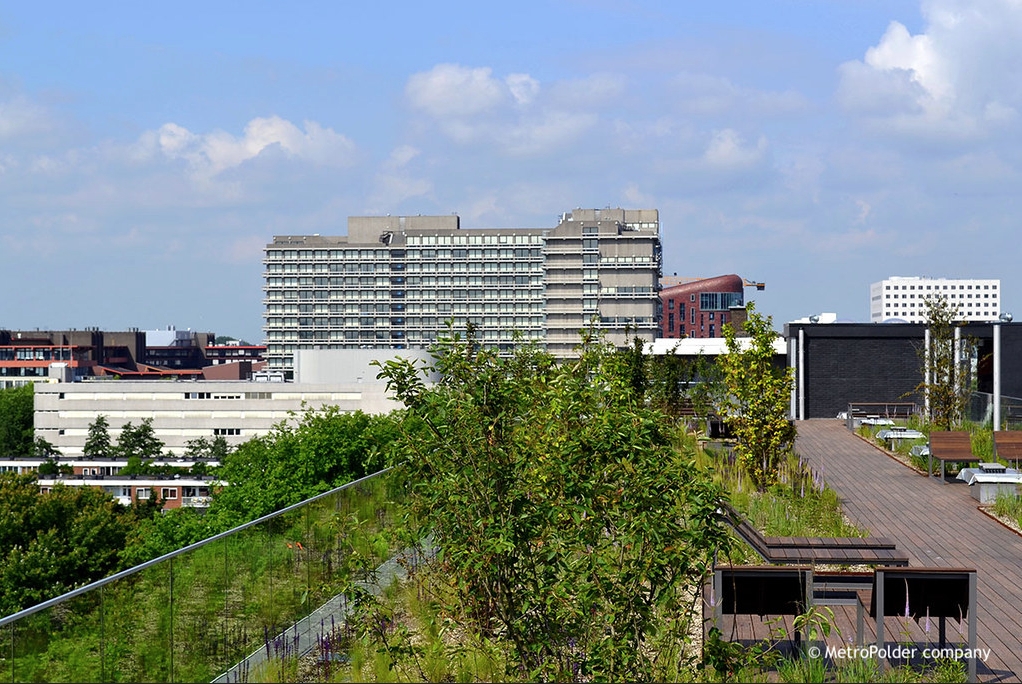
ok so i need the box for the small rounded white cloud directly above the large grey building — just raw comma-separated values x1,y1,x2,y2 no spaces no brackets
405,64,504,119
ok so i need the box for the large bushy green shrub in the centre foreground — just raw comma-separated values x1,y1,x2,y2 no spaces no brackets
380,331,727,680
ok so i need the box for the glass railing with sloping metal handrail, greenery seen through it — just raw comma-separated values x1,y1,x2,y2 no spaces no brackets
0,470,402,682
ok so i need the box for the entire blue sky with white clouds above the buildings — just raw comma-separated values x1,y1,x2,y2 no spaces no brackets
0,0,1022,341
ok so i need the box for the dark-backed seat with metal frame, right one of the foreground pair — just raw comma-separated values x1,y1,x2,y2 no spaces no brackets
870,567,976,682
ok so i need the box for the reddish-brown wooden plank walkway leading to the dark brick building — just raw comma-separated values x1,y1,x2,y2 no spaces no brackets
796,419,1022,682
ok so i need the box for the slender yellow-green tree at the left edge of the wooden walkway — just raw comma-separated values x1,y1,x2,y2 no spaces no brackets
715,302,795,491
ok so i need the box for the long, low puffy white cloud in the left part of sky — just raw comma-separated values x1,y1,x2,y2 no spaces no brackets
136,117,355,177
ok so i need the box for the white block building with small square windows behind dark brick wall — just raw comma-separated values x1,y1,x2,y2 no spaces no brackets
870,276,1003,323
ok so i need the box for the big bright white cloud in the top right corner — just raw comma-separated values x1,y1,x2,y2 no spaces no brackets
837,0,1022,140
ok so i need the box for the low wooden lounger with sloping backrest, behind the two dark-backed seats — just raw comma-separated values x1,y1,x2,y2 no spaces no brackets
721,503,909,566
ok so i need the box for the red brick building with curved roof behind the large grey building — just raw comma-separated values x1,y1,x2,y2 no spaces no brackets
660,275,745,339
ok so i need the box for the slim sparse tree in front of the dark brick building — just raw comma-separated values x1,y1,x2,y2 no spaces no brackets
916,297,975,430
